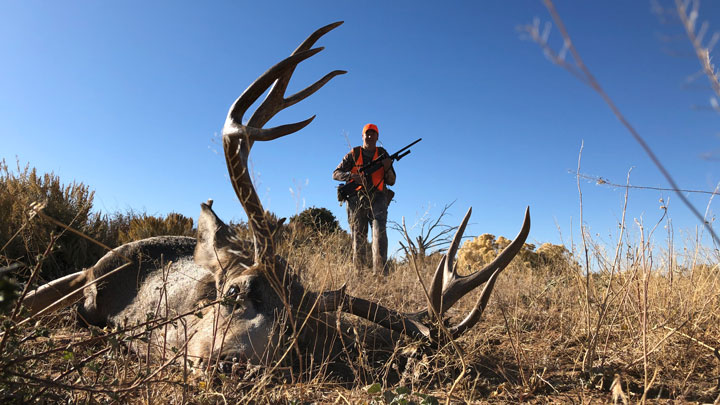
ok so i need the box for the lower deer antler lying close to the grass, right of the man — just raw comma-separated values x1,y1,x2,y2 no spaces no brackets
342,207,530,341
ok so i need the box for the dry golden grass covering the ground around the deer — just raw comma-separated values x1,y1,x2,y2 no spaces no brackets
0,166,720,403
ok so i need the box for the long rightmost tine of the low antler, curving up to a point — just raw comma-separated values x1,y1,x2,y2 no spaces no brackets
440,207,530,313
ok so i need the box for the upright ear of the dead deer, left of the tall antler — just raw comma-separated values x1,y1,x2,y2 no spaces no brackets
193,200,234,272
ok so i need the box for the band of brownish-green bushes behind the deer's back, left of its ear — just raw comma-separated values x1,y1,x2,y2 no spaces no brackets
0,160,200,281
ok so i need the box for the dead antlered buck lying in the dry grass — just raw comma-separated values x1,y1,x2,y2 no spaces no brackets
24,22,530,378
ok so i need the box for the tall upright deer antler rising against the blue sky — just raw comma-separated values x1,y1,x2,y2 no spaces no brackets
223,21,347,272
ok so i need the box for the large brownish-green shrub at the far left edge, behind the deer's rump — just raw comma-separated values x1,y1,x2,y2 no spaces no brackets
0,160,112,280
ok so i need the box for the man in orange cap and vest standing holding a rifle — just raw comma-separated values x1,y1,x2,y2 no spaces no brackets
333,124,395,274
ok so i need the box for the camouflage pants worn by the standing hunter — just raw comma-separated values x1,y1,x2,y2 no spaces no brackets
347,192,388,274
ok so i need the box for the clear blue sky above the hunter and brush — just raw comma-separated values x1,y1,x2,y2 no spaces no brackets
0,0,720,256
